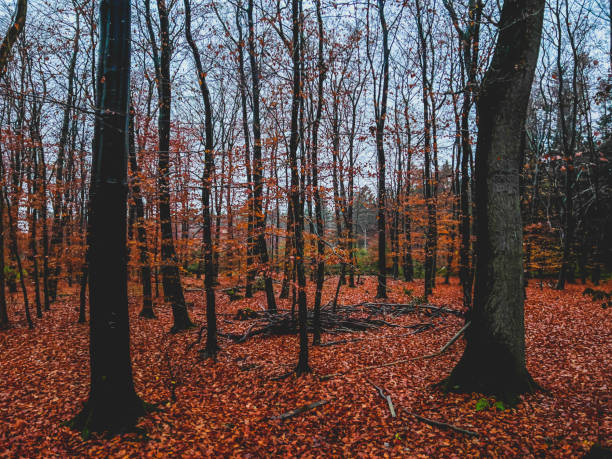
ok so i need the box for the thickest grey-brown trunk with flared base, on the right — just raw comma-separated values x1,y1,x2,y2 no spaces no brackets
444,0,545,403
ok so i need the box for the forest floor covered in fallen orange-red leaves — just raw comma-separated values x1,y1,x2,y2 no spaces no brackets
0,278,612,457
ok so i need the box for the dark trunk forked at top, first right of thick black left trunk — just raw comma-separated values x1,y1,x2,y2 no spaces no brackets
145,0,193,333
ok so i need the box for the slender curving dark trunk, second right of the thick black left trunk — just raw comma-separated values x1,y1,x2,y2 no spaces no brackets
184,0,219,357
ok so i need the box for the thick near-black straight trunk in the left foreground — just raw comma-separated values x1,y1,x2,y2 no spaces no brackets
70,0,145,436
